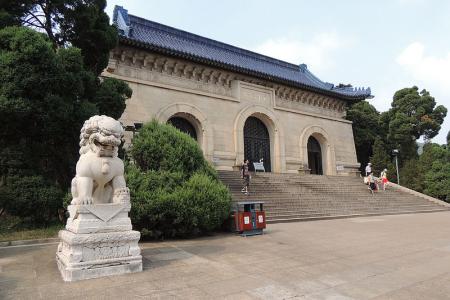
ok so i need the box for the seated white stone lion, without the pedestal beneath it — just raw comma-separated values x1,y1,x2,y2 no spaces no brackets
71,116,130,205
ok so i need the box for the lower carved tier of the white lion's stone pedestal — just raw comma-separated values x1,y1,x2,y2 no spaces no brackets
56,230,142,281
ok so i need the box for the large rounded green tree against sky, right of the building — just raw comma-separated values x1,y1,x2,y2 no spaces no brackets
381,86,447,164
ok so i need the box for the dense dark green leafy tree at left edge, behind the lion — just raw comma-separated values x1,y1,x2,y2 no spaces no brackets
0,27,97,186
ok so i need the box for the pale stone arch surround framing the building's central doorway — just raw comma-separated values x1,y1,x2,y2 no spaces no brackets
233,105,286,173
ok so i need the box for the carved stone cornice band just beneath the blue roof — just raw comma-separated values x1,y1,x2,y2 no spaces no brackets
107,46,346,118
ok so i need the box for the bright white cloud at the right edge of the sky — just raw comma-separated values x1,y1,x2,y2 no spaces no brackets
396,42,450,92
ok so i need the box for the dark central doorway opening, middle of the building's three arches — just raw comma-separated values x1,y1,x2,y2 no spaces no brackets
244,117,271,172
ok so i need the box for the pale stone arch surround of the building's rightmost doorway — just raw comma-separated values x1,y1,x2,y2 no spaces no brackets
300,125,336,175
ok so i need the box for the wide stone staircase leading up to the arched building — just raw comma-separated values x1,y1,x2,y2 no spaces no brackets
219,171,450,223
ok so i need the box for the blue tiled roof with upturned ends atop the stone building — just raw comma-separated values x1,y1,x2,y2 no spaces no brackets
113,6,371,100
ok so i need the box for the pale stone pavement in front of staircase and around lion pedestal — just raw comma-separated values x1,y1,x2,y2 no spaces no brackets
0,212,450,300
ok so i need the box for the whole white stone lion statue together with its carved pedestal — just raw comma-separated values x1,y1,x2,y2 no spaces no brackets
56,116,142,281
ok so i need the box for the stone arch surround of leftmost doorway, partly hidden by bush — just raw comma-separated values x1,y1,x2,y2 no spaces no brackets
156,103,214,161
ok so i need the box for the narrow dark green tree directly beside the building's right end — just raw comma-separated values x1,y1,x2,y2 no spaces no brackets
346,101,381,171
